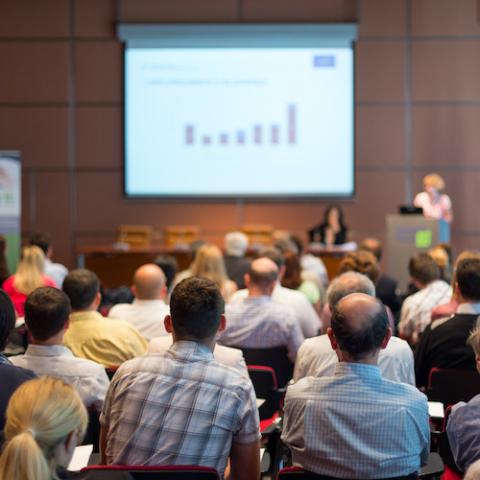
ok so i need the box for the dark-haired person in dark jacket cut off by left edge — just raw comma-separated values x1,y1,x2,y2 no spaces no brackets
0,290,35,432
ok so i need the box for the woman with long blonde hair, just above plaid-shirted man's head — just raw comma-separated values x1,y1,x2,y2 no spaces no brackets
190,243,237,302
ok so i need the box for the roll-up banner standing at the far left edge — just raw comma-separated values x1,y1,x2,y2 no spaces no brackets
0,150,22,273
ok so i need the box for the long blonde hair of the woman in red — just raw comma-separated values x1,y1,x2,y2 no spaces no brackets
13,245,45,295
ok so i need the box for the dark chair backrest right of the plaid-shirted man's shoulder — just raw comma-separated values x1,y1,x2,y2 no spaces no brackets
236,347,293,388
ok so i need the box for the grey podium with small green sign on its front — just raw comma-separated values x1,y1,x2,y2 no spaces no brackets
386,215,450,290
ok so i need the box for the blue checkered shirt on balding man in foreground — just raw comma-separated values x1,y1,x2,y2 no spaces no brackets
282,362,430,479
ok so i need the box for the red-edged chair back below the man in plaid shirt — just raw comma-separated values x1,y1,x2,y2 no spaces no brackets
82,465,220,480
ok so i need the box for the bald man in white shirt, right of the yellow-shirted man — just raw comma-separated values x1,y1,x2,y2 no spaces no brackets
108,263,170,340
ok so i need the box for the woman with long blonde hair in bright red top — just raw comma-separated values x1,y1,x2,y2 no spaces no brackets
3,246,56,317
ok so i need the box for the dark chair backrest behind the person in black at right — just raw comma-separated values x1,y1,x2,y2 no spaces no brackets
427,368,480,405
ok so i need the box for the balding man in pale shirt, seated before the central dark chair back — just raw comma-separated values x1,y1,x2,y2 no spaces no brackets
218,258,303,363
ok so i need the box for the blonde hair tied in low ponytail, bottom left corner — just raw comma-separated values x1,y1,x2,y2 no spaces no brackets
0,377,88,480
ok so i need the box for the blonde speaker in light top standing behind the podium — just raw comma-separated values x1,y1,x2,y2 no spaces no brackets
413,173,453,223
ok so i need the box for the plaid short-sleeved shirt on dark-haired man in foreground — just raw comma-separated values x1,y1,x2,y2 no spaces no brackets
100,341,260,475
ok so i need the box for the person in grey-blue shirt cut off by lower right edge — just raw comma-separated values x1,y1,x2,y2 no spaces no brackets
447,328,480,472
